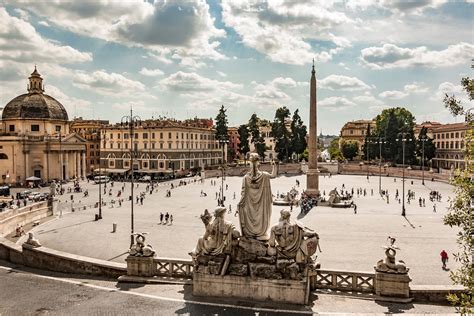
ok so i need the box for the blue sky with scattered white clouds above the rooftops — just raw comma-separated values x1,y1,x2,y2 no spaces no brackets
0,0,474,134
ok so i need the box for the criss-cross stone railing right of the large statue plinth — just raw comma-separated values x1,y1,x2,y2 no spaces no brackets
310,270,375,293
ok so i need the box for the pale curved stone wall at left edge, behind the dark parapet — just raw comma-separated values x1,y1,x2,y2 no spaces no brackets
0,201,53,236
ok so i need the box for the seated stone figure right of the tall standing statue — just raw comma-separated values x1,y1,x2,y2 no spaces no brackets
268,210,321,263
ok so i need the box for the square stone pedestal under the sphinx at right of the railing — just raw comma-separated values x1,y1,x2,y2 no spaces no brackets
375,271,413,303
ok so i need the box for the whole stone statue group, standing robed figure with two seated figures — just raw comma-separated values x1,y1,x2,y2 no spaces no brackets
189,153,319,279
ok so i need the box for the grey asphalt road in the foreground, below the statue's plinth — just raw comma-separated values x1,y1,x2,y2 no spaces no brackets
0,260,455,316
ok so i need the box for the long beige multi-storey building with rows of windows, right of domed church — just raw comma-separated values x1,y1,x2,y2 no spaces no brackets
101,119,222,176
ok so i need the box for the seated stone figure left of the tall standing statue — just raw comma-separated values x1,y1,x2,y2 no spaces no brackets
189,207,240,257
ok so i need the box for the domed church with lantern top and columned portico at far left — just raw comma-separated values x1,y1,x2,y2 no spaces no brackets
0,66,86,184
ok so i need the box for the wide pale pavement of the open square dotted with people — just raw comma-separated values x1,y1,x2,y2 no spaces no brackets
18,175,457,285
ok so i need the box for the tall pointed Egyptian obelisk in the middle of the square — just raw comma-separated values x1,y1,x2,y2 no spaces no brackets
305,59,319,197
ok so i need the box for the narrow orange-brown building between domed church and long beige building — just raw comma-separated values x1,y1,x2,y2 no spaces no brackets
69,117,109,173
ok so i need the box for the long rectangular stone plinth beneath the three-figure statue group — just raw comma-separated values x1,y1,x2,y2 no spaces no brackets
193,273,309,305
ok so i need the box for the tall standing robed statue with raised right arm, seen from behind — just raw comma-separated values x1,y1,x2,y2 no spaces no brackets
237,153,276,241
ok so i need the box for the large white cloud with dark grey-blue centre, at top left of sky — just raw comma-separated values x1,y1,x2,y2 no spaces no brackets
24,0,226,64
